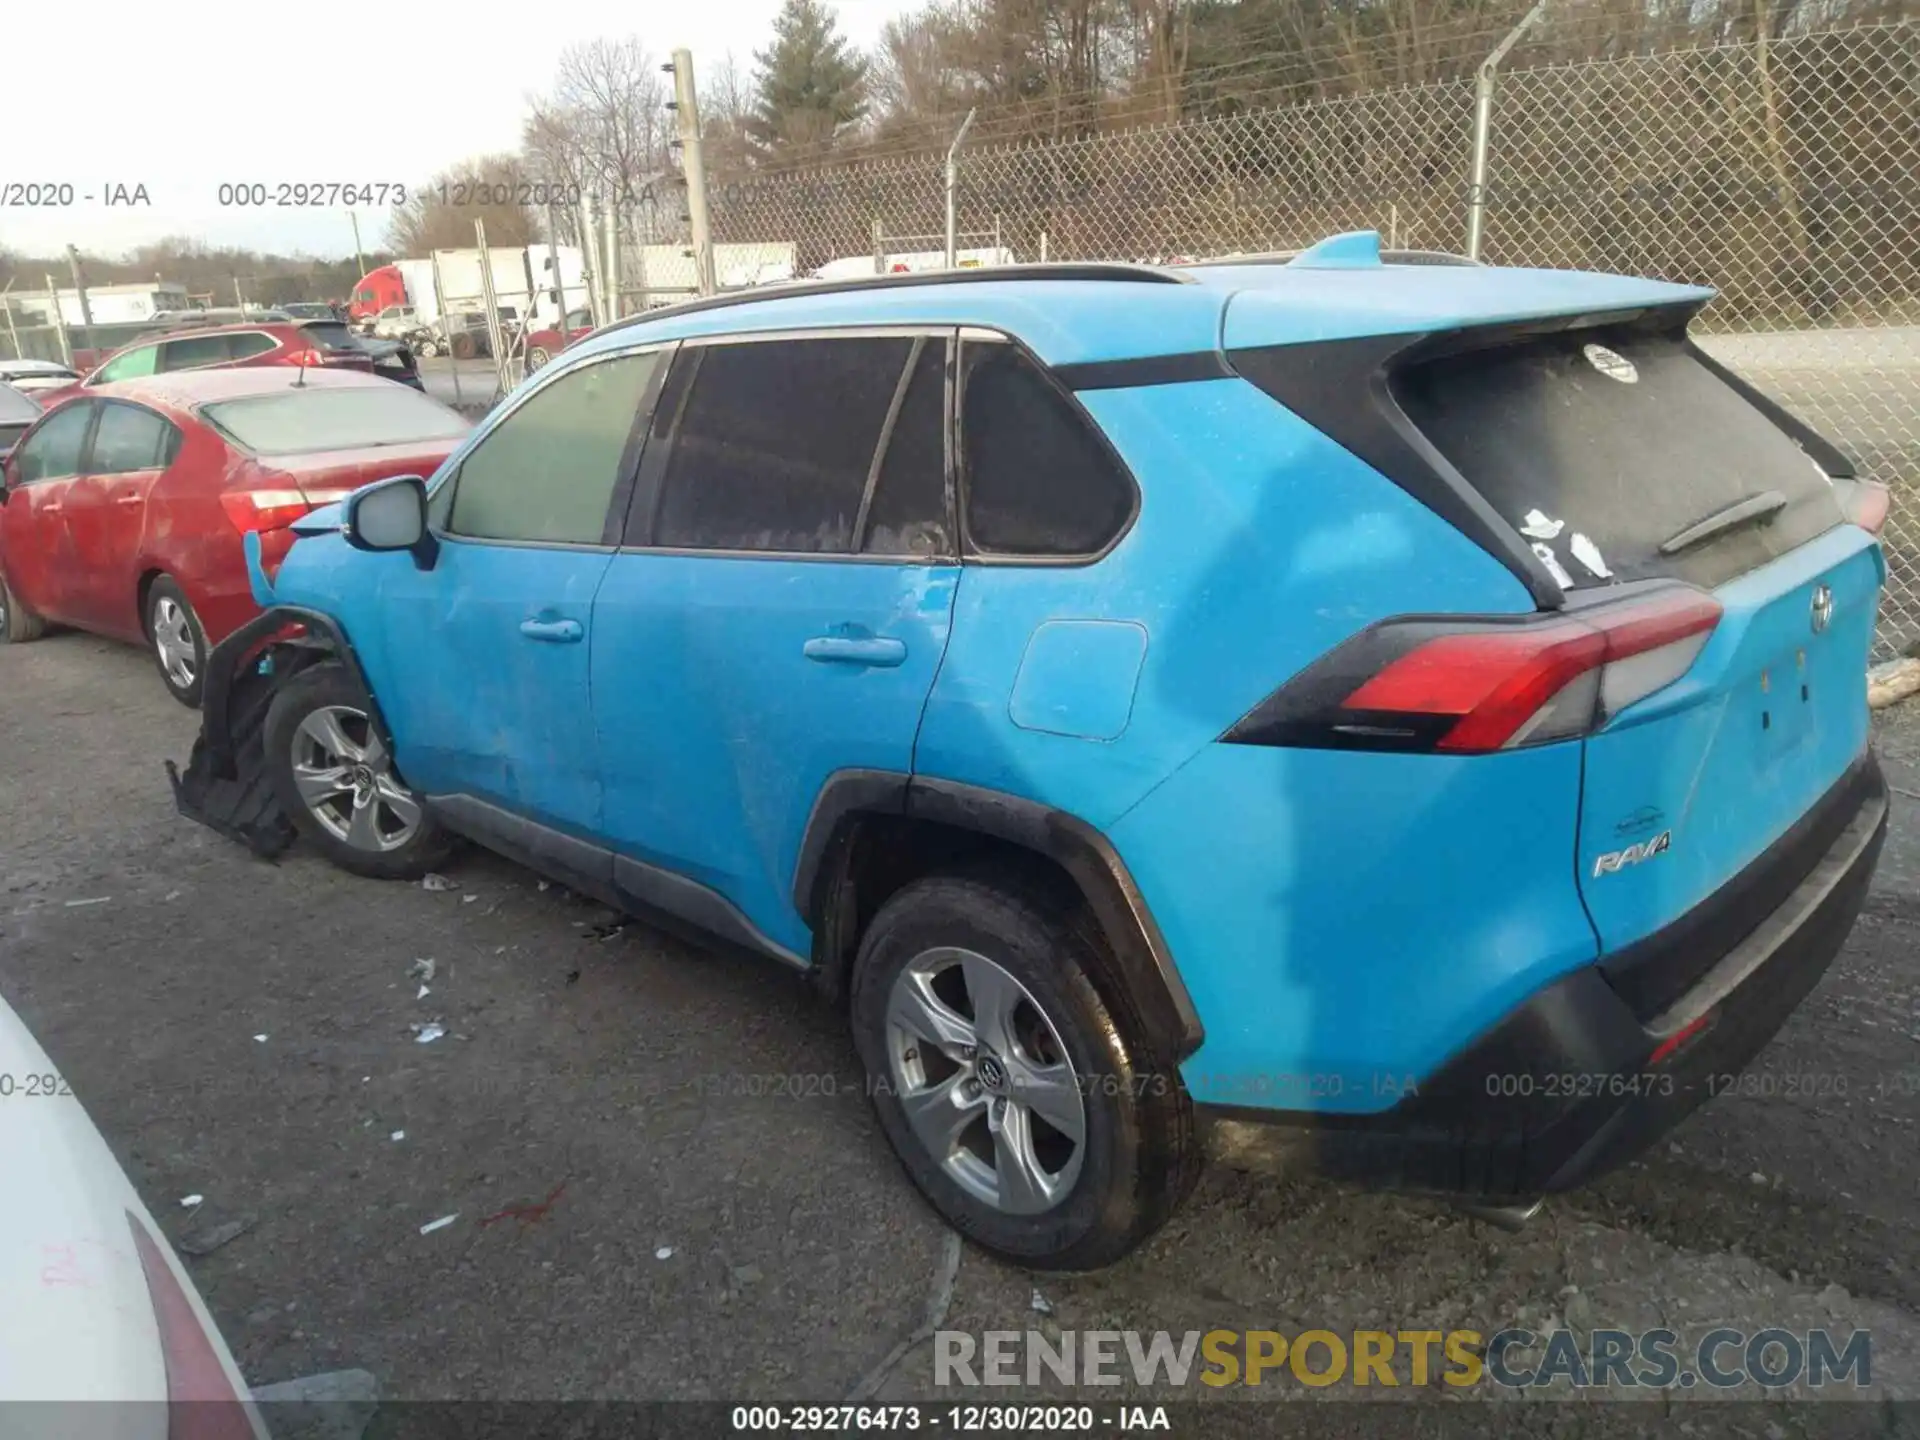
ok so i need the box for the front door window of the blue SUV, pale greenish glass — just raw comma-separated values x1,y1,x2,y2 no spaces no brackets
447,351,660,545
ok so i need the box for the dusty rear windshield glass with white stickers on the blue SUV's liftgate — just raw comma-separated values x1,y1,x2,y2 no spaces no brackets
1392,330,1841,588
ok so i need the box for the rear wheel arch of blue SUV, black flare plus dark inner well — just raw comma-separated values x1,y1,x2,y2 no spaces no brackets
793,770,1204,1064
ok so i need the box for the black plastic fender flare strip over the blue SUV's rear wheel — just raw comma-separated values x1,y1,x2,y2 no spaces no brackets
793,770,1206,1064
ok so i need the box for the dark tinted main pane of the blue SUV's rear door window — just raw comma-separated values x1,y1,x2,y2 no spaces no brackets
653,336,914,553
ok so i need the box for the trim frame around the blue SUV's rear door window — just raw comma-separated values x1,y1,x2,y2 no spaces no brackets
618,323,962,566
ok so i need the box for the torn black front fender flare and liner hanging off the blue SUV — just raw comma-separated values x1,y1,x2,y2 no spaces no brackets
167,605,386,860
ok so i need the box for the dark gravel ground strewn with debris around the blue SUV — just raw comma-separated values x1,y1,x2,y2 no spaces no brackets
0,634,1920,1436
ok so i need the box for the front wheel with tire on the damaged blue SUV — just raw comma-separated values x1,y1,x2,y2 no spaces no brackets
261,662,453,879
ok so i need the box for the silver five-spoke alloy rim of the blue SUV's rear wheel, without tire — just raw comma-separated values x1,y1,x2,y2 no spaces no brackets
887,947,1087,1215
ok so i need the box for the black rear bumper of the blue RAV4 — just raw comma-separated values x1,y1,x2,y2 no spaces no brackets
1202,753,1887,1200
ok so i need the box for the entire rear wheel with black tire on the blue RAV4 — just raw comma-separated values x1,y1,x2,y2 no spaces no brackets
851,876,1202,1271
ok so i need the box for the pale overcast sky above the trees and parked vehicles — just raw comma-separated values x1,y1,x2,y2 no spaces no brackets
0,0,906,257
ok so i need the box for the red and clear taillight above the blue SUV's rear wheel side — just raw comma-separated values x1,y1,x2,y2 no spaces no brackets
1223,586,1720,755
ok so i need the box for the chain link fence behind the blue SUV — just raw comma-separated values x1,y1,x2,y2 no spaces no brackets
708,23,1920,657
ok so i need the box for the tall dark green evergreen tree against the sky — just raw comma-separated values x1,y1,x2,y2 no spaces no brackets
747,0,868,159
